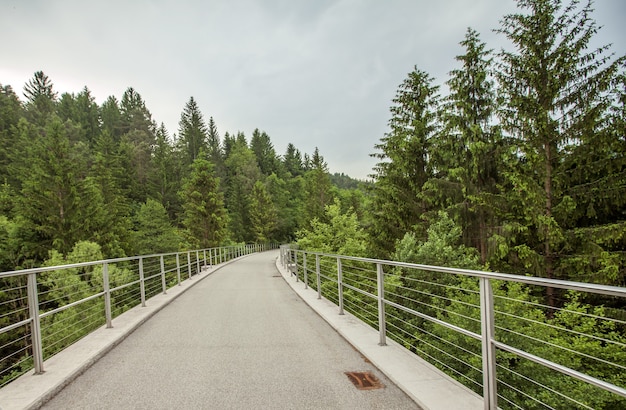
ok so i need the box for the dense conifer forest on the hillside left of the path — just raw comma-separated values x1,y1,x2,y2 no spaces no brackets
0,71,362,271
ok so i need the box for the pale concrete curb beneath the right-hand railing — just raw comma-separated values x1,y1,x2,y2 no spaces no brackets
276,258,484,410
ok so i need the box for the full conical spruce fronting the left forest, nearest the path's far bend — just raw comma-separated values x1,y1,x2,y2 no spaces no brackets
180,158,228,248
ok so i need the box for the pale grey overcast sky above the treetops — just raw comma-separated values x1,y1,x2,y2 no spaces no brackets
0,0,626,178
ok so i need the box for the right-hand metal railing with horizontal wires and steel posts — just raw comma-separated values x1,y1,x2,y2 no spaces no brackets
280,245,626,409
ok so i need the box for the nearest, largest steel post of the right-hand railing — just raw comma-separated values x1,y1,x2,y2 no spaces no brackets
479,278,498,410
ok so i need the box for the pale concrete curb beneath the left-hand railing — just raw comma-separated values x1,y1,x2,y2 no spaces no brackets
0,255,248,410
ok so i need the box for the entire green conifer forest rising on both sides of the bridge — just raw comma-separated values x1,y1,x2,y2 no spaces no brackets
0,0,626,408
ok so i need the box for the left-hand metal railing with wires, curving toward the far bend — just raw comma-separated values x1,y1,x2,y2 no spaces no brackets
0,244,275,387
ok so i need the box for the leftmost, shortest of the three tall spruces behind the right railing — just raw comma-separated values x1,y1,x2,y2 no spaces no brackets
370,67,439,257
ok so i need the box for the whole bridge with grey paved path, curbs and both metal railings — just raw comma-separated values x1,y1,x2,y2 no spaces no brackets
0,245,626,410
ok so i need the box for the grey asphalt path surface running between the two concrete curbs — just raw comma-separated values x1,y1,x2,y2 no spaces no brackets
43,252,418,409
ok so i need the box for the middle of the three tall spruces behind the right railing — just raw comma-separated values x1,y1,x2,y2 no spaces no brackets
428,29,502,263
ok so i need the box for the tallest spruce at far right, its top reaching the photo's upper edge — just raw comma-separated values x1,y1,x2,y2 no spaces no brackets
498,0,623,294
